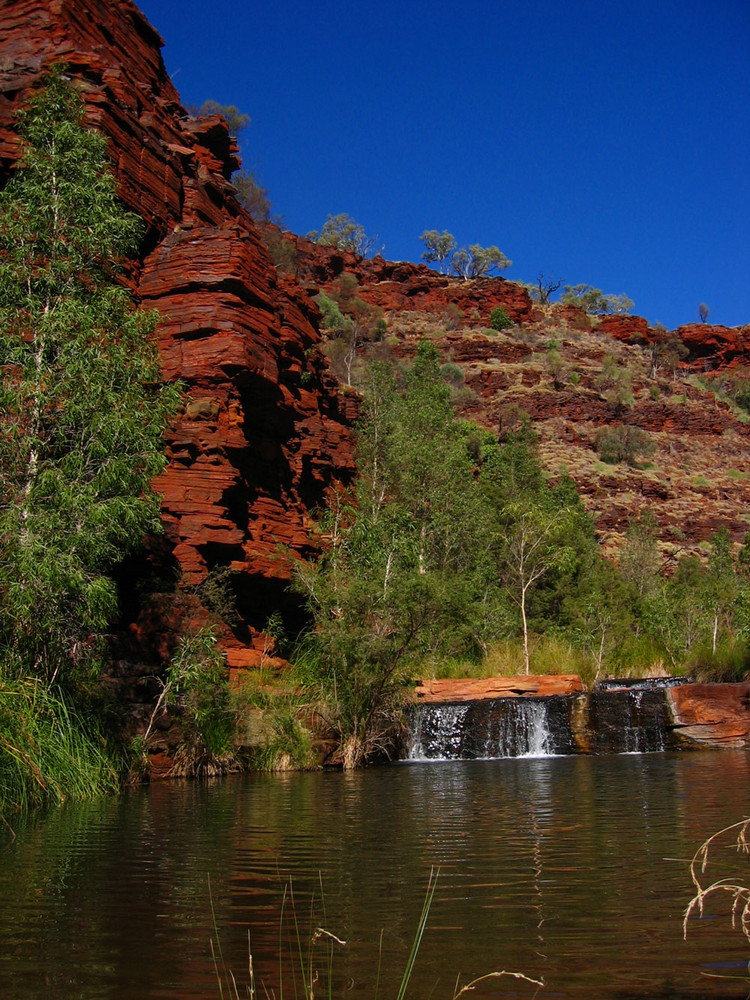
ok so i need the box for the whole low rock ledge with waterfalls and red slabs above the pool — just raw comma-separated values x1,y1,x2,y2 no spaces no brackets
403,676,750,761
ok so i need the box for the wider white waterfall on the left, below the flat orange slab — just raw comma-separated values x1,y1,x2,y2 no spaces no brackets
406,698,556,760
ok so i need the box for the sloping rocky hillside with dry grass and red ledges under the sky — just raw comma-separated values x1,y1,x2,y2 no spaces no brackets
294,238,750,558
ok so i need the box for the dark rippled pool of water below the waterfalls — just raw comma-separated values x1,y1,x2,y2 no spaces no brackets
0,751,750,1000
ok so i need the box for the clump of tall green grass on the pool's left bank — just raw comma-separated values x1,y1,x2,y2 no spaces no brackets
0,678,119,826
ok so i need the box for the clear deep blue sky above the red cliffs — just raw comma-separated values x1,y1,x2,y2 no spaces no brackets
136,0,750,328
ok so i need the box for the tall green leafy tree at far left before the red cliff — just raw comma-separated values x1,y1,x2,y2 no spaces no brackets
0,71,178,680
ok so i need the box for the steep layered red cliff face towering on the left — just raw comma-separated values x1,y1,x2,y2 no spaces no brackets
0,0,354,668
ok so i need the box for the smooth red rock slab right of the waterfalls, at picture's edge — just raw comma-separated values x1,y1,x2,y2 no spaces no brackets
668,681,750,747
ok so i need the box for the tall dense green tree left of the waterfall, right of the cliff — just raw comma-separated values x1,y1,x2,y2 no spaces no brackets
297,342,502,765
